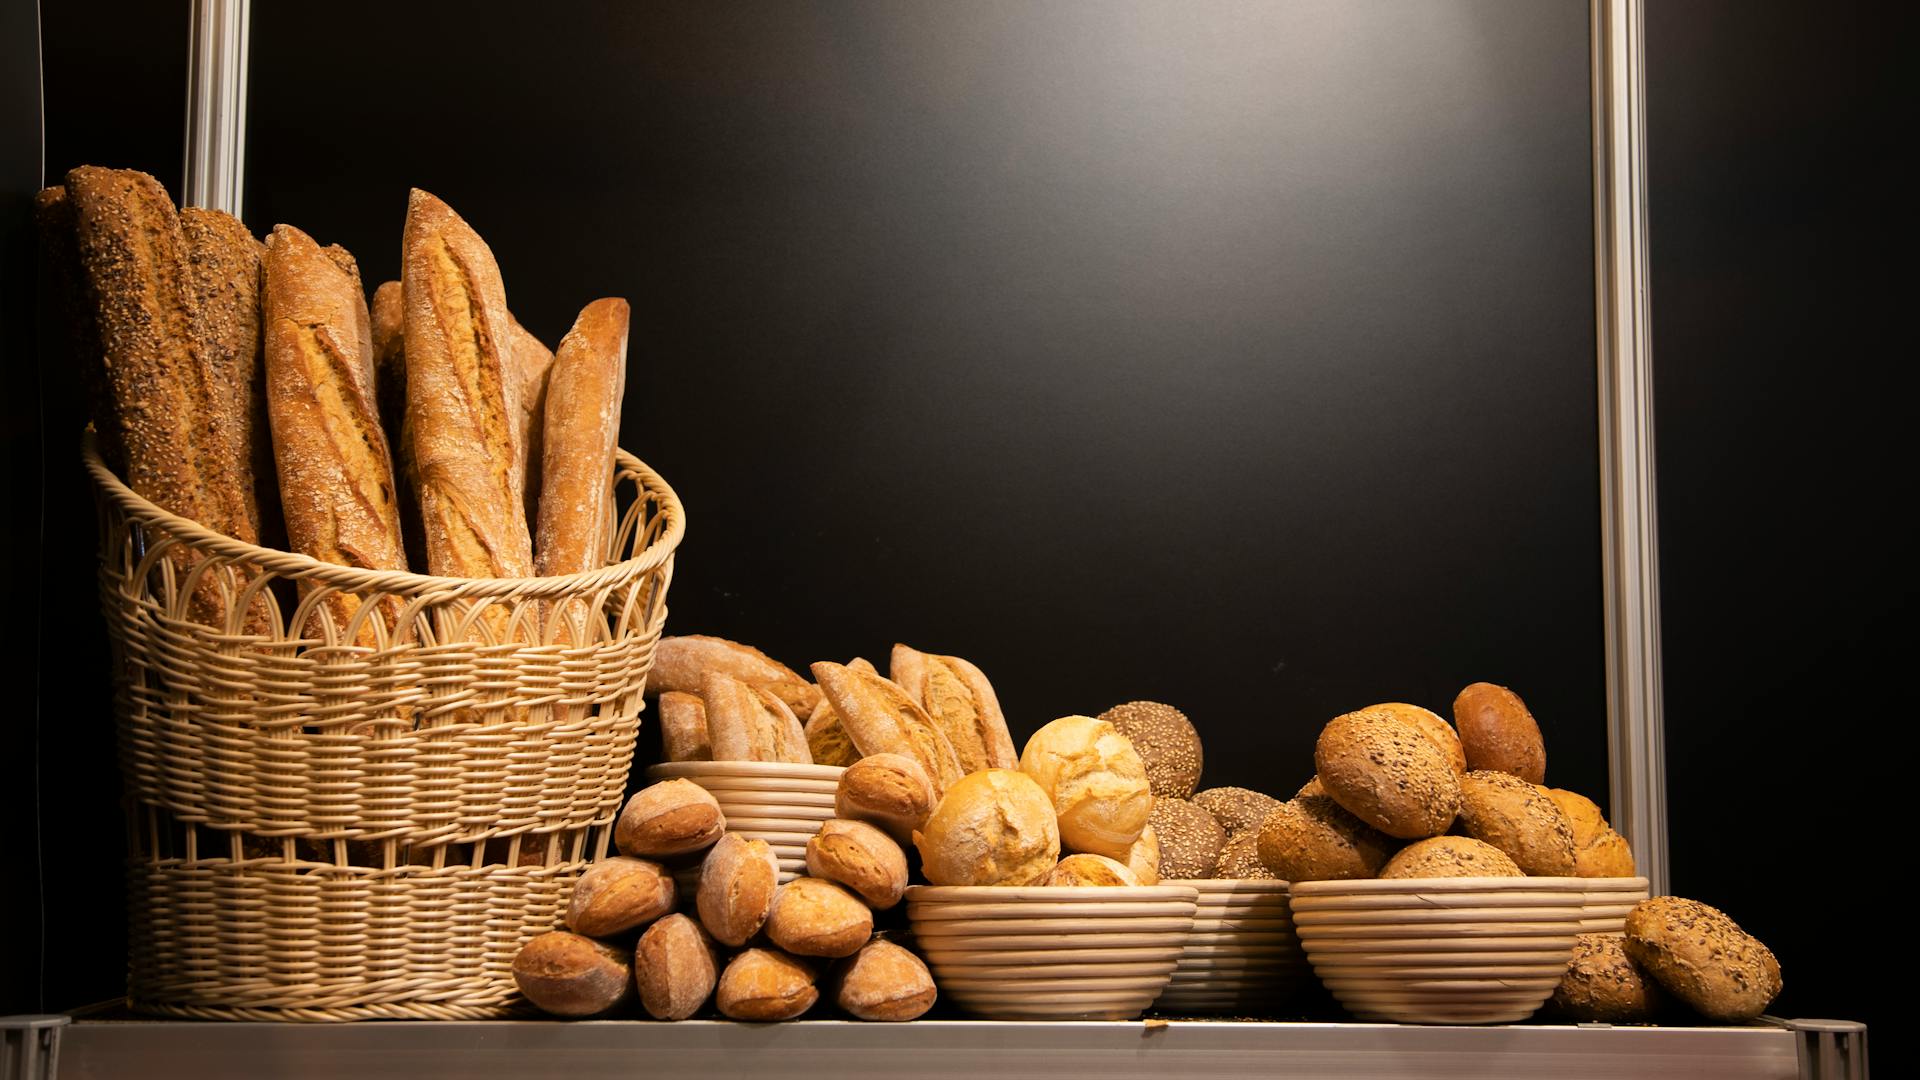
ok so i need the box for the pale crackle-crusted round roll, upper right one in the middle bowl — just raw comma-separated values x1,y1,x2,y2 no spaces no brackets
1020,717,1167,859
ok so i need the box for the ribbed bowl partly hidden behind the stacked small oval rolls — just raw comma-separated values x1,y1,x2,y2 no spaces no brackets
647,761,847,882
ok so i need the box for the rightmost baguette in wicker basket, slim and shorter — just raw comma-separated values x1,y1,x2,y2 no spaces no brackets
529,298,628,577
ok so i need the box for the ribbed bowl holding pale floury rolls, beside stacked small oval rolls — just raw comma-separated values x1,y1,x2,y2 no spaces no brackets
906,884,1198,1020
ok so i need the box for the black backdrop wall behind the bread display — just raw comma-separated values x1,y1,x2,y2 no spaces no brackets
11,2,1912,1063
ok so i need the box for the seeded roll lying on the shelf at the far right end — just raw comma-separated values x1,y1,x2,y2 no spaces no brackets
1626,896,1782,1024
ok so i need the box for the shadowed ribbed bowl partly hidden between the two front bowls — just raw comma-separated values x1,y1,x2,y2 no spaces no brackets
1154,878,1308,1017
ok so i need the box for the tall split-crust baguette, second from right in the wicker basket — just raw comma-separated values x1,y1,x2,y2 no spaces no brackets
401,190,534,584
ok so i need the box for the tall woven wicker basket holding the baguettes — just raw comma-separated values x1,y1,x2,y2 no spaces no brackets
83,430,685,1020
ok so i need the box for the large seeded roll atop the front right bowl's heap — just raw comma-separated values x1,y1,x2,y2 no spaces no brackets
1313,713,1459,840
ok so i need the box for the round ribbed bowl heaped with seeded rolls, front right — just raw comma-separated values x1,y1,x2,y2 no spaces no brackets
1290,878,1592,1024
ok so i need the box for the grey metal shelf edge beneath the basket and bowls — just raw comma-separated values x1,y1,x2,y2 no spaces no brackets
60,1020,1801,1080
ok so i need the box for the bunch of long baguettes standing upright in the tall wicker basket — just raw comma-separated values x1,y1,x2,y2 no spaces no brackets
36,165,628,644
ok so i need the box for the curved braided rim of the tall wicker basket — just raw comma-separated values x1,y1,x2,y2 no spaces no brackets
81,425,687,600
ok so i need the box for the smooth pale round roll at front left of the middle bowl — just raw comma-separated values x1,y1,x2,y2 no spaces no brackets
914,769,1060,886
